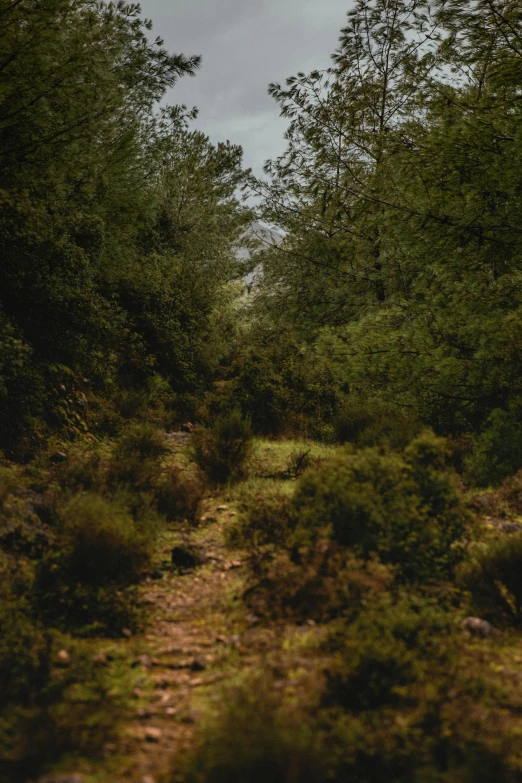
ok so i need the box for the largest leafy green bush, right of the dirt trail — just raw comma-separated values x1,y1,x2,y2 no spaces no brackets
293,432,468,581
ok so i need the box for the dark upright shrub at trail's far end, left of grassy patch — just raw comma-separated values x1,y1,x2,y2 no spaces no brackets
193,410,253,484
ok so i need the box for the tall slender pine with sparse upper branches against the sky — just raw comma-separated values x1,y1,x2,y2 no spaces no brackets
253,0,436,334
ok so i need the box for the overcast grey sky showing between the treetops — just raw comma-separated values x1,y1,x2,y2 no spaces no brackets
136,0,352,173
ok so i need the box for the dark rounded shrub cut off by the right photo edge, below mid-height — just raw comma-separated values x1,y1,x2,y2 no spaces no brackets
463,533,522,624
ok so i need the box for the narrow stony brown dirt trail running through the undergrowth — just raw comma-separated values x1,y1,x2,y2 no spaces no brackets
114,500,248,783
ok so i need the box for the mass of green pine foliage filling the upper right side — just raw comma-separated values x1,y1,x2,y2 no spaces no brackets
245,0,522,478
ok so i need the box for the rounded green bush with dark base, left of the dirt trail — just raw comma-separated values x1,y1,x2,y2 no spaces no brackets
33,493,148,635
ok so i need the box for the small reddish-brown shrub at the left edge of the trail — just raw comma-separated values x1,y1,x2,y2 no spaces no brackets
154,467,206,523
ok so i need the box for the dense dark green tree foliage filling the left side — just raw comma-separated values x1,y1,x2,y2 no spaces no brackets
0,0,250,456
